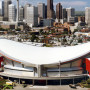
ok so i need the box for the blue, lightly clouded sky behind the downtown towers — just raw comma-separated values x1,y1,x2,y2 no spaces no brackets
0,0,90,11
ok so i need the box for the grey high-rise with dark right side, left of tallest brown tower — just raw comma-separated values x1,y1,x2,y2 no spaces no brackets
38,3,45,19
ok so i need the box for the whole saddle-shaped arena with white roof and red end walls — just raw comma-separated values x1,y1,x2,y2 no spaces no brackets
0,39,90,83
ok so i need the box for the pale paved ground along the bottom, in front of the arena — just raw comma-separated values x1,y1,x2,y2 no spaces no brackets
14,85,90,90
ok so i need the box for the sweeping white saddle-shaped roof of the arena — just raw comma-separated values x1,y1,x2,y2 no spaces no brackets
0,39,90,65
